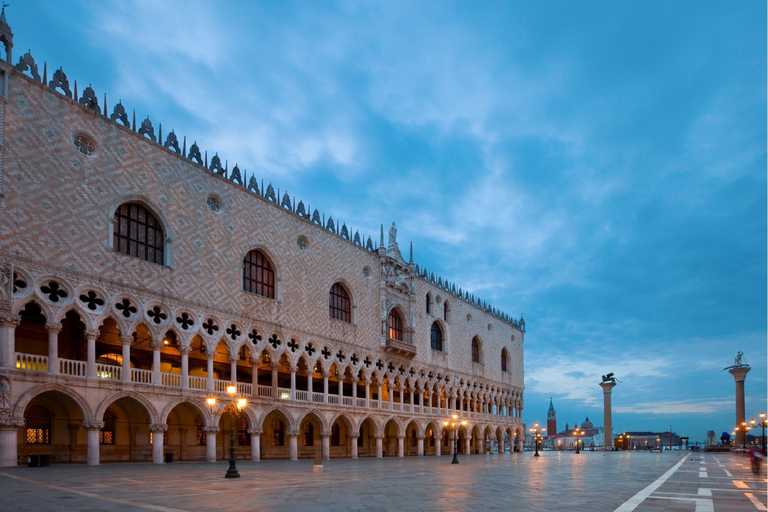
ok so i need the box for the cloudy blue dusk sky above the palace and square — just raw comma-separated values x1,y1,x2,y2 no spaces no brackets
6,0,768,442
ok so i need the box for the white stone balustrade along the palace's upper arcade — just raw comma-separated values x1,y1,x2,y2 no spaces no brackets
14,352,520,423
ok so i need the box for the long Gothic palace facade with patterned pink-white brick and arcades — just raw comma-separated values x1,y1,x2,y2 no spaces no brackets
0,13,525,466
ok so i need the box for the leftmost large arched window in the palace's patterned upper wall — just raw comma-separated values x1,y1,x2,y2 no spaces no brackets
112,203,164,265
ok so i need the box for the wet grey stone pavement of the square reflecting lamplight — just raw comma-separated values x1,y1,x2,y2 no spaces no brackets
0,452,766,512
